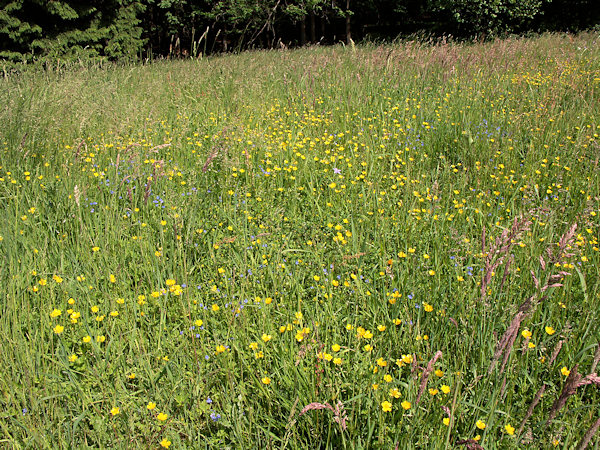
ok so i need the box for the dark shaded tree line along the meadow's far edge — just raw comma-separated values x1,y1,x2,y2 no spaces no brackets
0,0,600,62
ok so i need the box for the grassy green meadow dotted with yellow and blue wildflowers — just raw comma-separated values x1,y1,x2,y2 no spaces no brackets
0,33,600,449
